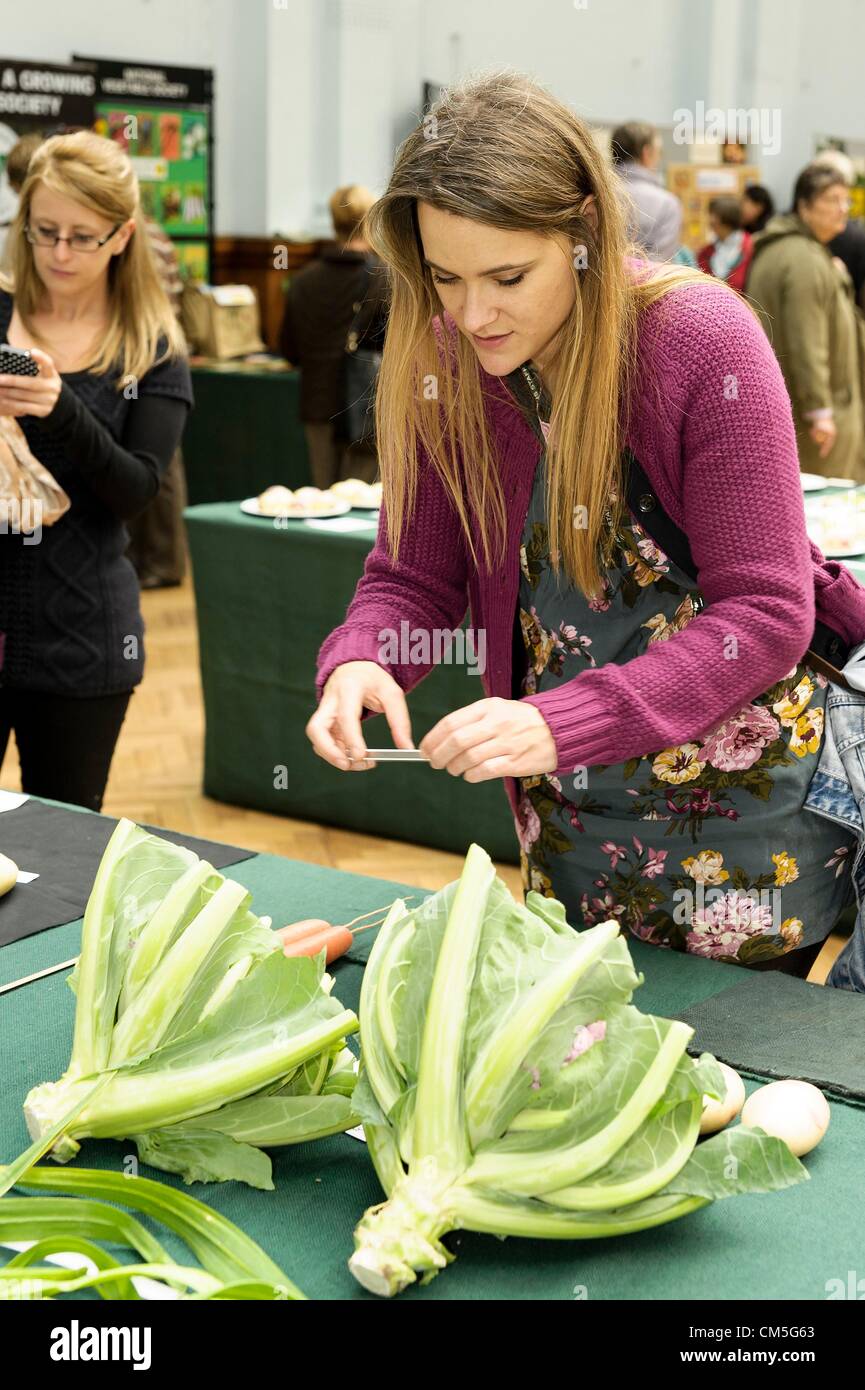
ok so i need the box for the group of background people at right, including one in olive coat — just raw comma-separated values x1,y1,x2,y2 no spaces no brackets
612,121,865,482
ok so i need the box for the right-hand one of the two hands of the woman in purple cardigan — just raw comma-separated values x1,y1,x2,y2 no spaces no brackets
419,698,558,781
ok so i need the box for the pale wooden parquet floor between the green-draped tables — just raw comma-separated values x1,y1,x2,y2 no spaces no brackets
0,578,843,983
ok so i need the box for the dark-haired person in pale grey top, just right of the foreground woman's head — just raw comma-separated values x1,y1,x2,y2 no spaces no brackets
611,121,681,260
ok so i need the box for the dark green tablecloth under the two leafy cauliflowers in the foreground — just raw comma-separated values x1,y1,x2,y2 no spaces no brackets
0,855,865,1302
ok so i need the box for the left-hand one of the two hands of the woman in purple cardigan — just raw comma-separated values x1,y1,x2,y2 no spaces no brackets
306,662,414,773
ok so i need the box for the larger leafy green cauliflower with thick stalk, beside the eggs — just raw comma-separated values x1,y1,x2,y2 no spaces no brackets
349,845,808,1295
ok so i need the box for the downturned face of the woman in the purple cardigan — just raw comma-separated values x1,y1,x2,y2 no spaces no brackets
417,202,576,377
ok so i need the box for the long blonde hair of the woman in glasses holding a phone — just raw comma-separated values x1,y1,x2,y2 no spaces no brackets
7,131,186,391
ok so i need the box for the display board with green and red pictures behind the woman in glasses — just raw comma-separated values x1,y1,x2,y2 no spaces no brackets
76,54,213,281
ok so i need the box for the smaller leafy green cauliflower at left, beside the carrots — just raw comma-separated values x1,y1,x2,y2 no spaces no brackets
20,820,357,1191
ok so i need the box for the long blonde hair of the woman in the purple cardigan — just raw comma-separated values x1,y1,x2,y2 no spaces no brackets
366,68,706,596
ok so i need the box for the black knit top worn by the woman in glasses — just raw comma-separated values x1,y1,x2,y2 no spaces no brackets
0,291,192,695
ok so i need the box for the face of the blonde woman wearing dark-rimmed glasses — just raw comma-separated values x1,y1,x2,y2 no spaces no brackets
28,183,135,297
